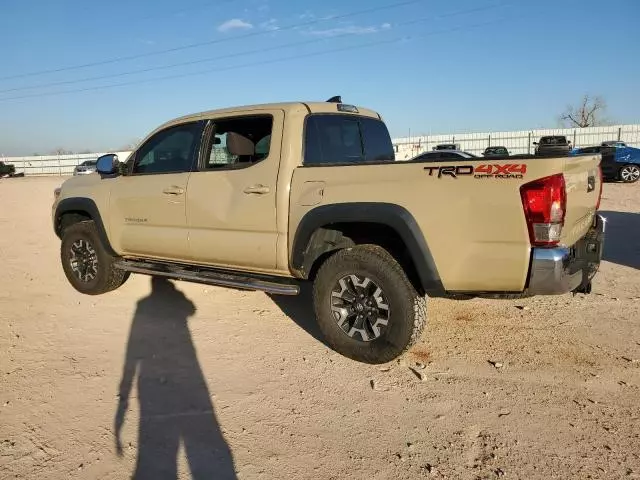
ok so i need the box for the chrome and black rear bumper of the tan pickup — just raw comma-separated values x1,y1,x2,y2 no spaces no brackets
527,215,606,295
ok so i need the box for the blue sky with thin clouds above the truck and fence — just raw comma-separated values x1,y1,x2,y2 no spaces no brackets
0,0,640,155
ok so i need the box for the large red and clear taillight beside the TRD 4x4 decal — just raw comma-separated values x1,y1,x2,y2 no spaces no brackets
520,174,567,247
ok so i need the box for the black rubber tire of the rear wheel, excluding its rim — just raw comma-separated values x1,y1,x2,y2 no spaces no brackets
313,245,427,364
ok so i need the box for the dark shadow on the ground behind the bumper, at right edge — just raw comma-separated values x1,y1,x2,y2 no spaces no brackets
600,211,640,269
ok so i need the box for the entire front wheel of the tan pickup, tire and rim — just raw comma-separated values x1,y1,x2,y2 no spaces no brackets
60,221,129,295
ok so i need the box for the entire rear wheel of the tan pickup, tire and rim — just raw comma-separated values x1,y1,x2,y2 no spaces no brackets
313,245,426,364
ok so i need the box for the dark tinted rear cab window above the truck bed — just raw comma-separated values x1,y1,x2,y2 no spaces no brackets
304,115,395,165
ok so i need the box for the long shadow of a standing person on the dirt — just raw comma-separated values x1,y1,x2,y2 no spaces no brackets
114,277,236,480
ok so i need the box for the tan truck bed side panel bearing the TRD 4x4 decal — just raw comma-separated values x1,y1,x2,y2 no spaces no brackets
288,158,600,292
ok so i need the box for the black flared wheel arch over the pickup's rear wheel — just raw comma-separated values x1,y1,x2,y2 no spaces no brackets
289,202,445,296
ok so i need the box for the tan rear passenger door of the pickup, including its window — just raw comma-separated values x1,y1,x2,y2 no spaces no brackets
187,110,286,272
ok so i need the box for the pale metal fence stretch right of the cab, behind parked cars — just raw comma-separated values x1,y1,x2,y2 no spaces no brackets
393,125,640,160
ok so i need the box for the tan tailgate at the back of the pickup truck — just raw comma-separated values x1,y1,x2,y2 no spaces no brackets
561,154,602,246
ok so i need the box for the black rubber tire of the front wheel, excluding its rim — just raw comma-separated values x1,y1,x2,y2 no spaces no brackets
60,220,130,295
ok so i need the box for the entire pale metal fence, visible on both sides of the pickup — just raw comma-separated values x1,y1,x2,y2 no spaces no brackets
0,124,640,175
